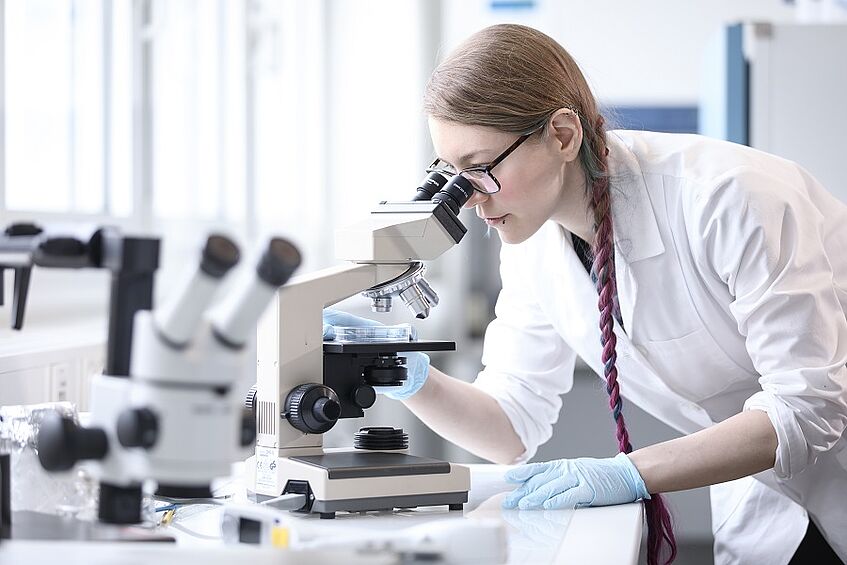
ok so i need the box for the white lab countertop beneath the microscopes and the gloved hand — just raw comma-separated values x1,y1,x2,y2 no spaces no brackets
0,465,643,565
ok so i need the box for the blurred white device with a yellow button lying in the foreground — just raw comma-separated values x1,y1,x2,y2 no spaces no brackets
221,504,508,565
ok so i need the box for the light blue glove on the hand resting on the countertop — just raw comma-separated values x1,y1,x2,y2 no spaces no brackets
503,453,650,510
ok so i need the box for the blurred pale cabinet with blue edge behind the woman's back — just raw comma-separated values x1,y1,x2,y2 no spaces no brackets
700,22,847,202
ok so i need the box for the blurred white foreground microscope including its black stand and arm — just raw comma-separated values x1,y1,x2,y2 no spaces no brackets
0,228,300,524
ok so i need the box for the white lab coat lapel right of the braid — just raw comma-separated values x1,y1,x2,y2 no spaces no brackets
606,131,665,264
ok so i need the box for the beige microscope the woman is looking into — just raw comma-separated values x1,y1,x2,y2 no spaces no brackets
245,171,480,518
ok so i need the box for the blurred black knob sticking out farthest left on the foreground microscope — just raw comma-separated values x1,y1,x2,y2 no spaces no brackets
38,413,109,471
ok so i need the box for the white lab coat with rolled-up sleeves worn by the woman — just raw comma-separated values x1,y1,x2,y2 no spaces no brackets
475,131,847,565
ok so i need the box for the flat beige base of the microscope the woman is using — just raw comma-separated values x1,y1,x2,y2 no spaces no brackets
248,450,470,518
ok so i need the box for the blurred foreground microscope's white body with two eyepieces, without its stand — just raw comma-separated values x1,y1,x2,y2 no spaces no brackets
122,236,300,498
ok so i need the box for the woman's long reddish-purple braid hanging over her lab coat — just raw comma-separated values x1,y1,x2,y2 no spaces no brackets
585,117,676,565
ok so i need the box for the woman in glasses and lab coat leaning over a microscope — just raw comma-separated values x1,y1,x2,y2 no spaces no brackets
328,25,847,563
